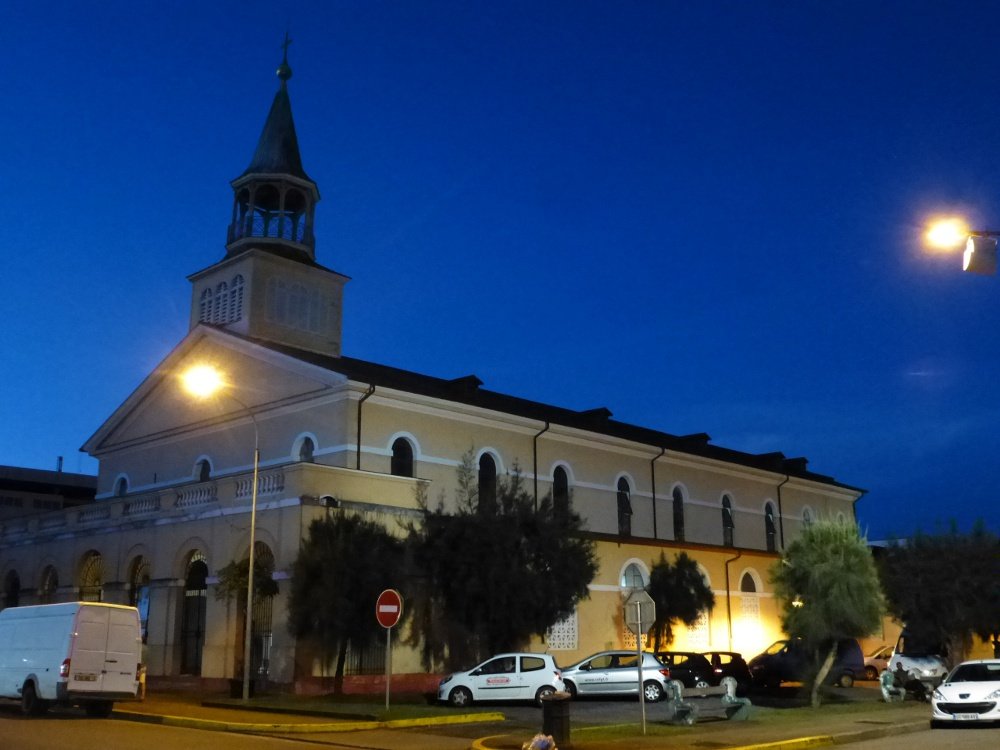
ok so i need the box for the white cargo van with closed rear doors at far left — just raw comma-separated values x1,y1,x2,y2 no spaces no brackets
0,602,142,716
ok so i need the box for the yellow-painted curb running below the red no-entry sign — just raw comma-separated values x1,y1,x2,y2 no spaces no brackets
112,710,506,734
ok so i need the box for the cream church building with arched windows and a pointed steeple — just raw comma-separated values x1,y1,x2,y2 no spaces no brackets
0,48,862,689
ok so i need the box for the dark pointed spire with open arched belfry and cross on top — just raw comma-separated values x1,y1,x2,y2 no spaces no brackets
226,39,319,261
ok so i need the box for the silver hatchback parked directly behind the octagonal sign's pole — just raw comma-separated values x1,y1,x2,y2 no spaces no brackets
563,651,670,703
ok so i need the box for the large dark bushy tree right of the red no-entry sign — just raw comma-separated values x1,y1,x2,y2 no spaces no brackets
410,451,597,669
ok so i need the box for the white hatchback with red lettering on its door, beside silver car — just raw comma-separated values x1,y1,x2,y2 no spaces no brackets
438,653,566,707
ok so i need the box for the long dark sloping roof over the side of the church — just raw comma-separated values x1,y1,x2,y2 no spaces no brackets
240,331,864,492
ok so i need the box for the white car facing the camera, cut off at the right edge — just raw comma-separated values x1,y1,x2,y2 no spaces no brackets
931,659,1000,727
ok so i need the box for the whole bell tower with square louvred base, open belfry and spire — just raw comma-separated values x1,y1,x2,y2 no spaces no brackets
188,34,348,357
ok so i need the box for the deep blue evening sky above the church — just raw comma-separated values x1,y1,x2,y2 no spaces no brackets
0,0,1000,539
